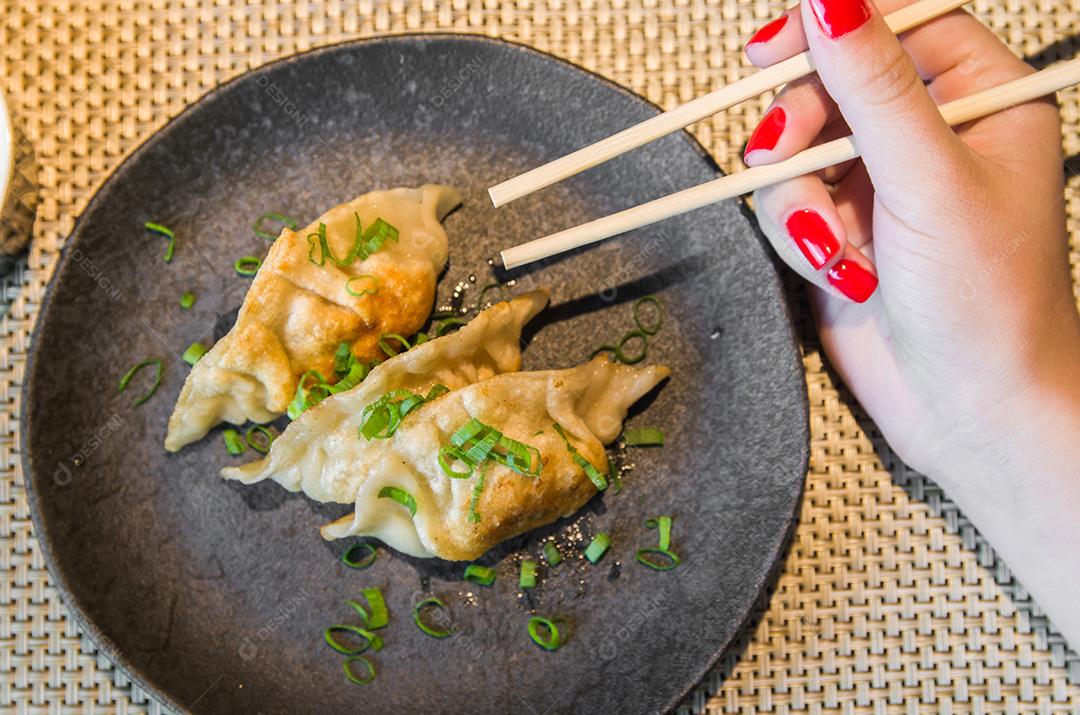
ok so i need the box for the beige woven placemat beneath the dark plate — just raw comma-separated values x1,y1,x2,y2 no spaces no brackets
0,0,1080,713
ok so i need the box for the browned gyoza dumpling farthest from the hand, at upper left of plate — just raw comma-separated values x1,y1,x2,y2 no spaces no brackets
165,184,461,451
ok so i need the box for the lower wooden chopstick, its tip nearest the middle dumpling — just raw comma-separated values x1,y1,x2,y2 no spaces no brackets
502,58,1080,268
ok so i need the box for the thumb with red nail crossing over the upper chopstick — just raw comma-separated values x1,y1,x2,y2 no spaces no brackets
802,0,963,208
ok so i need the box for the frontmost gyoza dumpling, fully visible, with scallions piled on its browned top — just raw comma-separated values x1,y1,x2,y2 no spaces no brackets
320,358,670,561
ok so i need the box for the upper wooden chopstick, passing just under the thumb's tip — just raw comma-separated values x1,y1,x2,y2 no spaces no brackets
487,0,969,206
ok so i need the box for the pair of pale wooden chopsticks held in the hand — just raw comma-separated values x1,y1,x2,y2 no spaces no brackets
488,0,1080,268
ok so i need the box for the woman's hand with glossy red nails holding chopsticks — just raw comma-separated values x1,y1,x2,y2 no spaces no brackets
745,0,1080,645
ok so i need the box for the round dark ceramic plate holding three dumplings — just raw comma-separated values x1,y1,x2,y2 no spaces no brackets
23,36,808,713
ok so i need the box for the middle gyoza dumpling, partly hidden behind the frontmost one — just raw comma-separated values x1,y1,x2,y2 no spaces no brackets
221,291,548,503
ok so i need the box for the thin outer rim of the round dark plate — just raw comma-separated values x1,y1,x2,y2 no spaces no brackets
18,31,810,713
